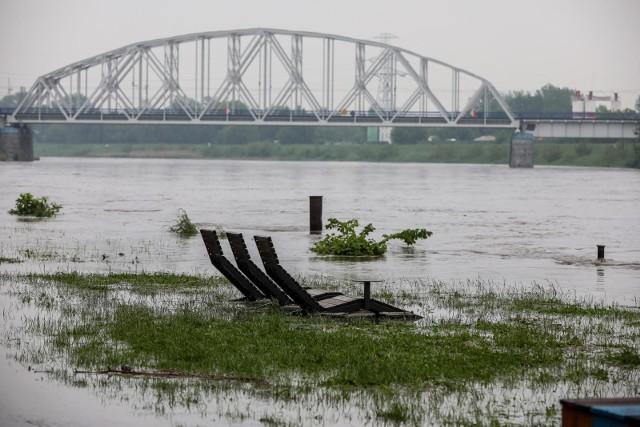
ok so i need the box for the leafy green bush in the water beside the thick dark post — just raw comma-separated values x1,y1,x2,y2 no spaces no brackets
311,218,432,256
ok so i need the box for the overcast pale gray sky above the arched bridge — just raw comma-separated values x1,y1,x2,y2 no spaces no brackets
0,0,640,107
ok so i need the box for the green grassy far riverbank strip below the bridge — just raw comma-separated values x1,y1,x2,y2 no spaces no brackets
34,141,640,167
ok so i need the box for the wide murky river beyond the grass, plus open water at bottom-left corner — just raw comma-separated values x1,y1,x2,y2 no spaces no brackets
0,158,640,425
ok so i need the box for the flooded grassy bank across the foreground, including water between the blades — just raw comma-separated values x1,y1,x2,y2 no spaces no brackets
0,273,640,426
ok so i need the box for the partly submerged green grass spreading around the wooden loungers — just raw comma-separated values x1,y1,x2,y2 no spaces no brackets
5,273,640,425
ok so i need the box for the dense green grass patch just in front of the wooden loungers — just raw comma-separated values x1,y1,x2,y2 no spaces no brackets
70,306,567,389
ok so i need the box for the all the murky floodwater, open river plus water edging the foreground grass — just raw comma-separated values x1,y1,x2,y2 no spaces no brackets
0,159,640,425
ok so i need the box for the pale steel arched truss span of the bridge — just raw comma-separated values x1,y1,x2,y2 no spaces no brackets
11,28,518,128
